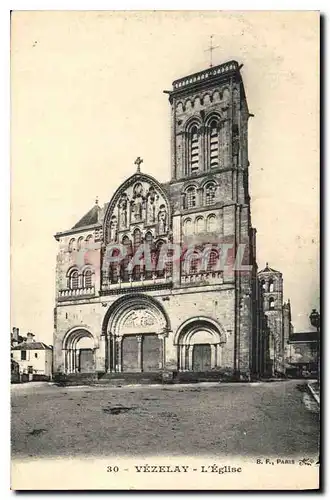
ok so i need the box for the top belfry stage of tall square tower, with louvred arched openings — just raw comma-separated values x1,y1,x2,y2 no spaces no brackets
168,61,250,203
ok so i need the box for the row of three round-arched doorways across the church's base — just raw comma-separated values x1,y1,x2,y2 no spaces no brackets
63,297,225,373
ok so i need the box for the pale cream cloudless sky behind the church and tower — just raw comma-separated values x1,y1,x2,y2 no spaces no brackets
11,11,320,343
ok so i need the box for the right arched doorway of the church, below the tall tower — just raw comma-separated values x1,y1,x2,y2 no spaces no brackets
175,317,226,372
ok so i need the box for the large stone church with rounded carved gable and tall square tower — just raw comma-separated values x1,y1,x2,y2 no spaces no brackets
54,61,290,379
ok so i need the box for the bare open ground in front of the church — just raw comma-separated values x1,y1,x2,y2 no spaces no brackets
11,380,319,458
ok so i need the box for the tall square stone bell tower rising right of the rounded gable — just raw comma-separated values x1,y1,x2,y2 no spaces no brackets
166,61,259,373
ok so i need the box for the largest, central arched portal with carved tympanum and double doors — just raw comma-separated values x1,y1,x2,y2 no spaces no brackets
103,295,169,372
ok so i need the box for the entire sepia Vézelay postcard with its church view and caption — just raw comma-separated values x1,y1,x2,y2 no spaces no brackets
10,10,321,490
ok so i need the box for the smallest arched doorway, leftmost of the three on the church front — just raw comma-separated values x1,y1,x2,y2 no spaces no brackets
63,328,95,373
